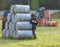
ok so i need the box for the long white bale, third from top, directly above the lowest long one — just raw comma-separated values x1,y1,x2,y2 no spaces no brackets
16,22,32,30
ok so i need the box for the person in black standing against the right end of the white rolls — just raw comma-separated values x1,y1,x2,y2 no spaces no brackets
30,14,38,39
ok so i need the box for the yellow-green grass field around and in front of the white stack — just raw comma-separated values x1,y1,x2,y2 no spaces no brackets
0,19,60,47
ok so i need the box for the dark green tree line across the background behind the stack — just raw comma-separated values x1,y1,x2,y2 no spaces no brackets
0,0,60,11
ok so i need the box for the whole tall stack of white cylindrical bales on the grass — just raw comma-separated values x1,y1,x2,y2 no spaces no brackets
2,5,33,39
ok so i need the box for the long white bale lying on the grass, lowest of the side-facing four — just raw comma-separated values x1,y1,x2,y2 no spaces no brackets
16,30,33,39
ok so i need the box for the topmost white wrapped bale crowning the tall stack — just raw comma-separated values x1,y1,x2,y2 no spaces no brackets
11,5,30,13
